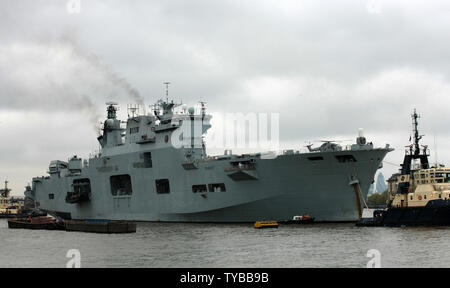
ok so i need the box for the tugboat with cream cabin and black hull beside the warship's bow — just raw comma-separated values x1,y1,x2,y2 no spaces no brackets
357,110,450,226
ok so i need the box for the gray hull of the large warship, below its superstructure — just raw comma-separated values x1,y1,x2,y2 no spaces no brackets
32,148,390,222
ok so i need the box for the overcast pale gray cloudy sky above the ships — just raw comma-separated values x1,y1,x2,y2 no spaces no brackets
0,0,450,195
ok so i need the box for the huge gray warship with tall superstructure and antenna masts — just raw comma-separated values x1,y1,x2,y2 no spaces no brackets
25,100,393,222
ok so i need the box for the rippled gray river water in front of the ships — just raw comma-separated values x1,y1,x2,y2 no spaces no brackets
0,219,450,268
